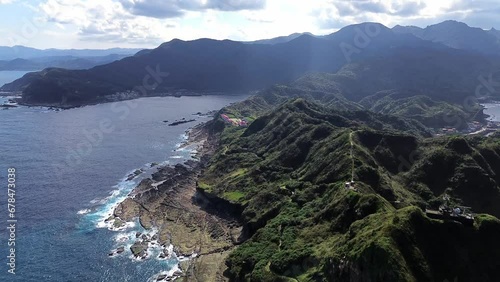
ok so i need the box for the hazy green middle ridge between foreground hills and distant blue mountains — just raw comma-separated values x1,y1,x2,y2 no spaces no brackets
227,69,485,132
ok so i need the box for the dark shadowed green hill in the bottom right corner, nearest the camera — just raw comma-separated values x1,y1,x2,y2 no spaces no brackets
323,207,500,281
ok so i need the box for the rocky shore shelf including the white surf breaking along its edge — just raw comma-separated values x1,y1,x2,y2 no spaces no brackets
103,121,243,281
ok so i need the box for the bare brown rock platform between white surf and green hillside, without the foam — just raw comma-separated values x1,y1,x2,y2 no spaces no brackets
111,127,238,281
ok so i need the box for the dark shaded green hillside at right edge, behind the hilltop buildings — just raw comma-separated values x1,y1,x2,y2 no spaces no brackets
401,137,500,217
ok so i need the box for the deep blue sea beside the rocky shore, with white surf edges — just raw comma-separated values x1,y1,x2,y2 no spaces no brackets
0,70,245,281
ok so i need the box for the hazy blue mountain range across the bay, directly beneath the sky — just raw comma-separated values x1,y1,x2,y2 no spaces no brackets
1,19,500,109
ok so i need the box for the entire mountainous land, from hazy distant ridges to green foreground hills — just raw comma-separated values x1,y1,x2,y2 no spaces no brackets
0,18,500,282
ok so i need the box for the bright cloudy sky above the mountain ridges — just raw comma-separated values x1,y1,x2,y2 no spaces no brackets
0,0,500,49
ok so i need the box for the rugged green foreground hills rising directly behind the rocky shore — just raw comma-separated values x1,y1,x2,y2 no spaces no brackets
198,99,500,281
